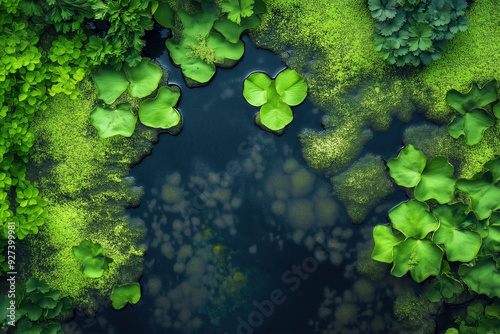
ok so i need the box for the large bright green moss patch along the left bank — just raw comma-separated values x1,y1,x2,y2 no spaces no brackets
24,79,157,313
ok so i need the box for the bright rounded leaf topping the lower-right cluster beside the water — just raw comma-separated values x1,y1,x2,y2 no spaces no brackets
389,200,439,239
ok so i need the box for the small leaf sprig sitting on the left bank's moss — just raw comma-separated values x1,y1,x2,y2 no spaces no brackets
73,240,113,278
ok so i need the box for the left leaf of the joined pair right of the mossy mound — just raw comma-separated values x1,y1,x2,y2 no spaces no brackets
387,145,427,188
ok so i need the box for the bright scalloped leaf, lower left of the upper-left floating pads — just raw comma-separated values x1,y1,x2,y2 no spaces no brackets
90,103,137,138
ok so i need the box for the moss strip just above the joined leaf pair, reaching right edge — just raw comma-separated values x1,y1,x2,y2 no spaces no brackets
404,122,500,178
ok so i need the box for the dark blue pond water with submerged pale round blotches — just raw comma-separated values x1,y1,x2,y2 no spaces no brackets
68,37,438,334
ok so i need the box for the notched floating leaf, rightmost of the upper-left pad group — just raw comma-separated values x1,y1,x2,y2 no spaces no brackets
139,87,181,129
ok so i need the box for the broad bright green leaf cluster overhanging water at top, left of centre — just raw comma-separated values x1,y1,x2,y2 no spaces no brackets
154,0,265,84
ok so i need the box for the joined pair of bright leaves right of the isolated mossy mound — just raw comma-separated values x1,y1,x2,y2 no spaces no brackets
387,145,456,204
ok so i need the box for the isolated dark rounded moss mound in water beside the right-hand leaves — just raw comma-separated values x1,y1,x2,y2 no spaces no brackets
331,155,393,224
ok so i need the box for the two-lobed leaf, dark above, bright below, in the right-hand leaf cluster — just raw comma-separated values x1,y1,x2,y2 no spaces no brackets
432,203,481,262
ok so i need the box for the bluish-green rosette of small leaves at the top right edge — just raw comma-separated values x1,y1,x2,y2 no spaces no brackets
368,0,468,66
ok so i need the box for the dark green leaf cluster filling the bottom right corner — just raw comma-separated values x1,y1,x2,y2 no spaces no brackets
445,300,500,334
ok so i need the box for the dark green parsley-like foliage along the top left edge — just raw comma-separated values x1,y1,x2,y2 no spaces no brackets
19,0,158,67
